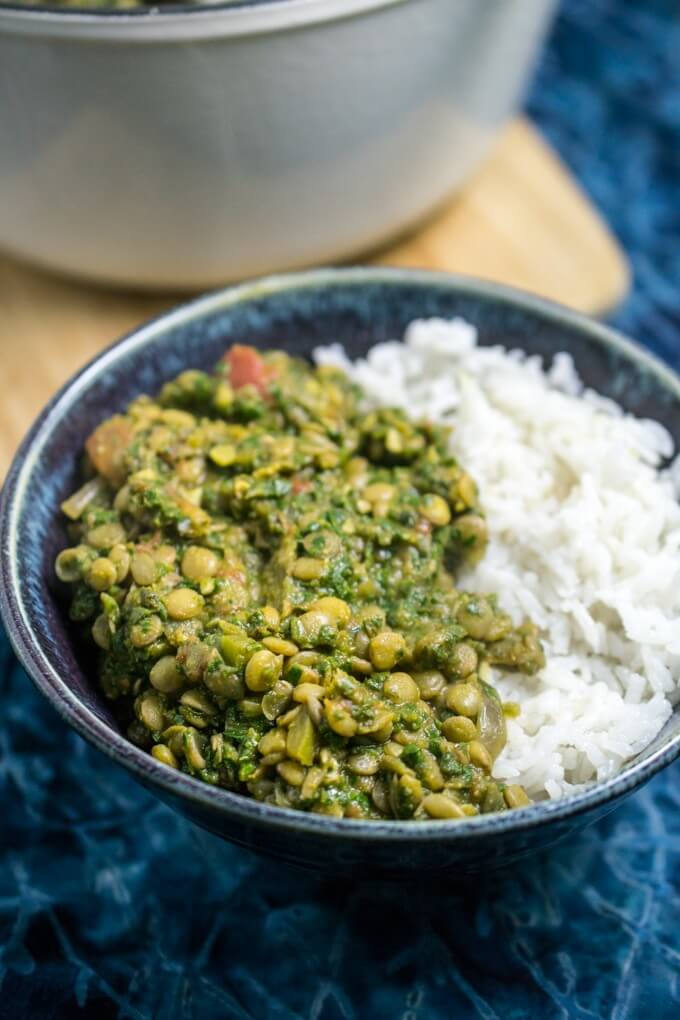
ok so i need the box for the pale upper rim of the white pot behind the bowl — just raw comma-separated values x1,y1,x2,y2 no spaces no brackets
0,0,403,43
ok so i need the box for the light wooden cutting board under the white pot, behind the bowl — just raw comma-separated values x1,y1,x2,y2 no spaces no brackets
0,118,629,479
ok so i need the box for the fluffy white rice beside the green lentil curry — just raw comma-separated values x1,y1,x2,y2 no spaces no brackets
315,319,680,798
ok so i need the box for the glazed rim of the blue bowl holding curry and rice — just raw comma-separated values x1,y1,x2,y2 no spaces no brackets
0,267,680,844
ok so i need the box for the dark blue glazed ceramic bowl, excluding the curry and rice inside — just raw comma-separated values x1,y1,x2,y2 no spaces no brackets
0,269,680,877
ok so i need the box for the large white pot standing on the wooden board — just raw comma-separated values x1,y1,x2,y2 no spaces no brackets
0,0,555,288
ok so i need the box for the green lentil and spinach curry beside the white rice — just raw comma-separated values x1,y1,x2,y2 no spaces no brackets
56,346,543,819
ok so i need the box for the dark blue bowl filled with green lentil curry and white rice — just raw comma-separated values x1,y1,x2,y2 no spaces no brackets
2,270,680,874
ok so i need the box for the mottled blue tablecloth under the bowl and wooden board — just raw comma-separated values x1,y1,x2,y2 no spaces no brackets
0,0,680,1020
